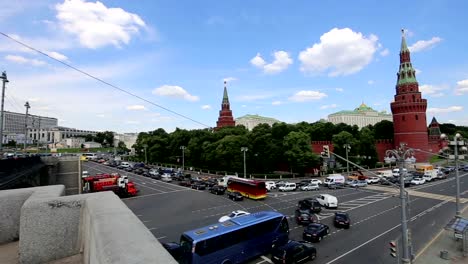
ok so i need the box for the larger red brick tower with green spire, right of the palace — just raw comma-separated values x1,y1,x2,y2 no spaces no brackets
390,30,429,162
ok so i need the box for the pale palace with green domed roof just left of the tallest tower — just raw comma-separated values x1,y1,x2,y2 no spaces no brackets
328,103,393,128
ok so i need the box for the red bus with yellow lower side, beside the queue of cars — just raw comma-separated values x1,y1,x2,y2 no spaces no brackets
227,177,267,200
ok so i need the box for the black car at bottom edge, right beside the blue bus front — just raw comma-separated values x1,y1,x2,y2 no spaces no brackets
271,240,317,264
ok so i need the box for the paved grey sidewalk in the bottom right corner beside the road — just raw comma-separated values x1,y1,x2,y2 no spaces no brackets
413,206,468,264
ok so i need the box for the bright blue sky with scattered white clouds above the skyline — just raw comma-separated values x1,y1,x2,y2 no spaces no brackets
0,0,468,132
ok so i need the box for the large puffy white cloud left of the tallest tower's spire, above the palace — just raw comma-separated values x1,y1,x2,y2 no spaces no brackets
299,28,379,76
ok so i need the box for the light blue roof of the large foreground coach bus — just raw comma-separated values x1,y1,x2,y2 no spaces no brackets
183,211,284,242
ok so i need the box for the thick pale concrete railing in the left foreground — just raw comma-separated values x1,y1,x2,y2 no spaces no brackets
0,185,176,264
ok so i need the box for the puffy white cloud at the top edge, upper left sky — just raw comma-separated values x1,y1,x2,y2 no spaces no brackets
55,0,146,49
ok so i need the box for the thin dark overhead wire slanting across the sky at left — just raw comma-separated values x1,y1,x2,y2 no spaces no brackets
0,32,211,128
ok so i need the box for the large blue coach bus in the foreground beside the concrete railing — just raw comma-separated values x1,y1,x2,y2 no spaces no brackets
172,211,289,264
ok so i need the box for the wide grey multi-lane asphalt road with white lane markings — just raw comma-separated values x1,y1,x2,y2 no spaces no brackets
83,162,468,264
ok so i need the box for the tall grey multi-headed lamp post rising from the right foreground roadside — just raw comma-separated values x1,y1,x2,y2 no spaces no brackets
385,144,415,263
